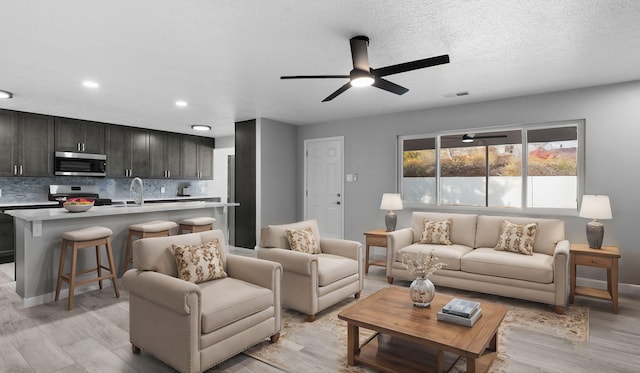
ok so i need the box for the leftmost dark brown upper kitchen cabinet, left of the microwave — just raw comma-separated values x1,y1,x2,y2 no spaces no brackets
0,110,54,177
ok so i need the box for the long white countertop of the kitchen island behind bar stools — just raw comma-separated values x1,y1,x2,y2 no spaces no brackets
4,201,240,221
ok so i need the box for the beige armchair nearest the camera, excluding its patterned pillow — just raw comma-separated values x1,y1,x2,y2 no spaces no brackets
122,230,282,372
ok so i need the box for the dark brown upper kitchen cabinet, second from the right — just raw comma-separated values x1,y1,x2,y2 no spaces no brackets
149,131,182,179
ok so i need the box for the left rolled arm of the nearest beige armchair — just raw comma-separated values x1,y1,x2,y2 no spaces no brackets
122,269,200,315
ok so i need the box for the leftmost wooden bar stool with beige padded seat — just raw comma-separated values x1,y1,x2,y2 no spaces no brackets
56,227,120,311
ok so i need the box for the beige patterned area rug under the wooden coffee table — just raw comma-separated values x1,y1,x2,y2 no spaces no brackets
244,288,589,373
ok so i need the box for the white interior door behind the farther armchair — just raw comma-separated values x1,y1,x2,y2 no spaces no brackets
304,137,344,238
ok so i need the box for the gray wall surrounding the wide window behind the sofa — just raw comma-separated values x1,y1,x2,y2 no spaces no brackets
298,82,640,285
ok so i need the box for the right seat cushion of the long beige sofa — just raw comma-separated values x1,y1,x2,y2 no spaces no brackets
461,247,553,284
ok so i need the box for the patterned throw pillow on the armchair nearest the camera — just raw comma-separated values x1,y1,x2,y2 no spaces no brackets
173,239,227,284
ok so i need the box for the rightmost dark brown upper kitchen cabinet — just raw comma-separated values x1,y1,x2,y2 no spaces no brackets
182,135,215,180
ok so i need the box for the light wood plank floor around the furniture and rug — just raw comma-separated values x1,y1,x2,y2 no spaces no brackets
0,249,640,373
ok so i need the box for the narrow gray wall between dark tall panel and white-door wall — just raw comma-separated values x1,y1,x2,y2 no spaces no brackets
257,118,298,230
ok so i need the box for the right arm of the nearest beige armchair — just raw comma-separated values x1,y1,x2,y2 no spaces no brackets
227,254,282,290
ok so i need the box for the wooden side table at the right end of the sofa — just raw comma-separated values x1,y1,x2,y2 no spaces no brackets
569,244,620,313
